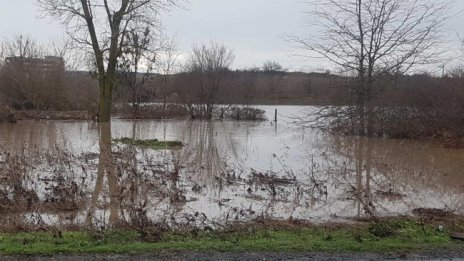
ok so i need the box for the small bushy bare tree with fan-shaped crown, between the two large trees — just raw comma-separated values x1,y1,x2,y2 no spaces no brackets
180,42,234,120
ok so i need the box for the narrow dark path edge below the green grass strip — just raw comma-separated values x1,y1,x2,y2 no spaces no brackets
0,252,464,261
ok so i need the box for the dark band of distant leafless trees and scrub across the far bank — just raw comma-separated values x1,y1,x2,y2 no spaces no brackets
0,67,464,109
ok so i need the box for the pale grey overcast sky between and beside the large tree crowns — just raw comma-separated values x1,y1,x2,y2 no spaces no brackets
0,0,464,71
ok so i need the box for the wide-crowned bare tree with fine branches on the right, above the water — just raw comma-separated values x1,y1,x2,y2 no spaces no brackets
290,0,448,136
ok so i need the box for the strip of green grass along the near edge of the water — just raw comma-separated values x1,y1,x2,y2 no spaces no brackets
0,221,464,255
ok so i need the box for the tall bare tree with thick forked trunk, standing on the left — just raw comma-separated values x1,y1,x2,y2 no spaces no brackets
36,0,176,122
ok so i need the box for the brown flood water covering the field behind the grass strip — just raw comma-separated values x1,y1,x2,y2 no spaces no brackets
0,106,464,226
